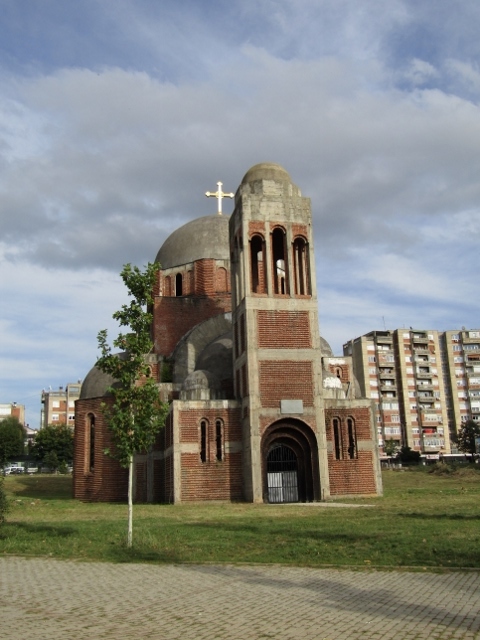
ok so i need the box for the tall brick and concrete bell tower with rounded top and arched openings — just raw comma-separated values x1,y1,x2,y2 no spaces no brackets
230,163,330,502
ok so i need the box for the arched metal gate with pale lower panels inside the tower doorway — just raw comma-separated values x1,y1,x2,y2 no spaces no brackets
267,444,298,502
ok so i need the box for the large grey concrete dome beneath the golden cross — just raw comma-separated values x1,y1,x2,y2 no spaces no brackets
155,214,230,269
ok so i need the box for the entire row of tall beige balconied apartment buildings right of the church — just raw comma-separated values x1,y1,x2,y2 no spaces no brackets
343,329,480,457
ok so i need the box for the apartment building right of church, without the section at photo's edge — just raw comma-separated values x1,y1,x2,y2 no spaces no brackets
343,329,451,456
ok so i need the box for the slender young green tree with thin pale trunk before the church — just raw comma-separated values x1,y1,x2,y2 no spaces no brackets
97,263,168,547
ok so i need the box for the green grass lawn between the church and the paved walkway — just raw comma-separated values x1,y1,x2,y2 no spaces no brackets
0,469,480,569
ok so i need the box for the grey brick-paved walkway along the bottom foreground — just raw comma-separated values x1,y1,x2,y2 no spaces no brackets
0,557,480,640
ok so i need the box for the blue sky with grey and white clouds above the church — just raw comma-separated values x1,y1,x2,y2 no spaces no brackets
0,0,480,428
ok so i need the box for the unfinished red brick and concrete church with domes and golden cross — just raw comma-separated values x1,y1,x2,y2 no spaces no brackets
74,163,382,503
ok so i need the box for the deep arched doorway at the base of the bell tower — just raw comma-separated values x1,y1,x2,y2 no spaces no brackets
262,419,320,503
